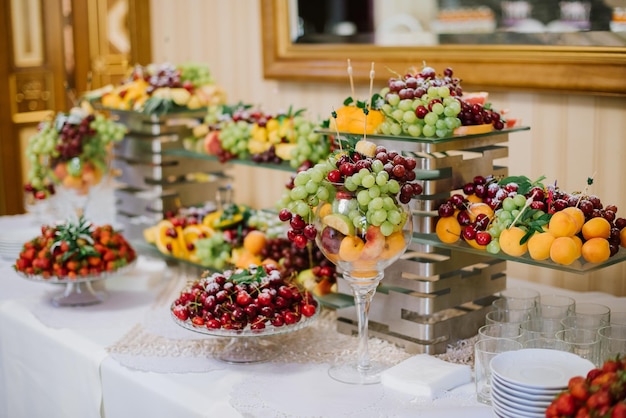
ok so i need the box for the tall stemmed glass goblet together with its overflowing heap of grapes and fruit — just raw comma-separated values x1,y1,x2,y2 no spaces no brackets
279,140,422,384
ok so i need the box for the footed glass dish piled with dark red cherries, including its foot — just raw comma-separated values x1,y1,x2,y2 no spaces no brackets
170,265,320,363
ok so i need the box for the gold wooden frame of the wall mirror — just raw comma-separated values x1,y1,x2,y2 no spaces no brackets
260,0,626,95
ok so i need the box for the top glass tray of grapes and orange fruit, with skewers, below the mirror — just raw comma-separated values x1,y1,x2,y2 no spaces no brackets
320,65,528,143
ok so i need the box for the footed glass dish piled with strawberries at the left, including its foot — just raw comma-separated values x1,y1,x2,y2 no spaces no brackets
13,216,137,306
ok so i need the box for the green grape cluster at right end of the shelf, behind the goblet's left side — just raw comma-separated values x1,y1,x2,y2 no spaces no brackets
289,117,330,168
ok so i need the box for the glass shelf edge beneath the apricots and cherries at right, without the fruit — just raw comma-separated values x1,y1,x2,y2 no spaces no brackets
413,233,626,274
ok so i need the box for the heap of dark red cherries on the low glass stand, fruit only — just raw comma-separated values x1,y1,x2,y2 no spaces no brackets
171,265,318,330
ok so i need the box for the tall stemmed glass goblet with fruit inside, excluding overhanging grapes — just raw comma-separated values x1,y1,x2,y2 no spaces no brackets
315,189,413,384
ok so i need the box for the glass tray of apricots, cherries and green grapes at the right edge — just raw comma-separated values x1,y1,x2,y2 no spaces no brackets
426,176,626,273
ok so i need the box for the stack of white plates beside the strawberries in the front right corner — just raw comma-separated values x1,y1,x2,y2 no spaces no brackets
491,348,595,418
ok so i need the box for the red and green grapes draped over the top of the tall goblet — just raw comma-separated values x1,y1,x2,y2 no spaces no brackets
279,140,422,248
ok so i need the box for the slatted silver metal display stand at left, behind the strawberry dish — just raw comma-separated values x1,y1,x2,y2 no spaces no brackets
110,110,228,239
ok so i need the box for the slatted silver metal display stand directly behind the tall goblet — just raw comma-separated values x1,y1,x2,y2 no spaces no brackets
327,128,528,354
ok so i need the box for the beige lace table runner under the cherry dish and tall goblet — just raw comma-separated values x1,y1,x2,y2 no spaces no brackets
107,277,473,373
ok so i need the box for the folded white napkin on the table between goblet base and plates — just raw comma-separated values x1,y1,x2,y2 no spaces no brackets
381,354,472,399
